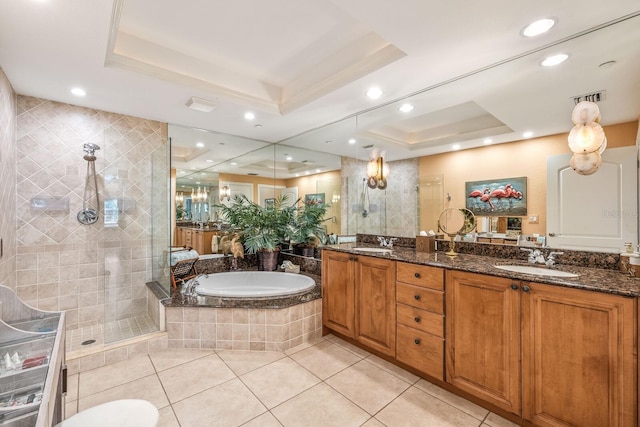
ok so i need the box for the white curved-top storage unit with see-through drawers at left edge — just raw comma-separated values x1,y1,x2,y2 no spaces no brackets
0,286,66,427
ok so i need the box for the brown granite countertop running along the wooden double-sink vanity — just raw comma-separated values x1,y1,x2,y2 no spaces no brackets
324,244,640,297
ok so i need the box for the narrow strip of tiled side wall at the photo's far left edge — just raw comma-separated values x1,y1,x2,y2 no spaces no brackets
0,68,16,290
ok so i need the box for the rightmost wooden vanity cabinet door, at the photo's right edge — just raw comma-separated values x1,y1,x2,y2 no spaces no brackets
522,284,637,427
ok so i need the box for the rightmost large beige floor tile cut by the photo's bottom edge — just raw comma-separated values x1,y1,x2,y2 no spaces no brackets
376,387,480,427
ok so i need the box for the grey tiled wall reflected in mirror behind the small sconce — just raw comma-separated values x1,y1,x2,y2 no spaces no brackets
341,157,418,237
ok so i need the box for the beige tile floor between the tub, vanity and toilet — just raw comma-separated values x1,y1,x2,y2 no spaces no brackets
67,335,515,427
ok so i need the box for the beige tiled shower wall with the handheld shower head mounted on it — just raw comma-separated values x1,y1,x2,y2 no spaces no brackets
16,96,166,329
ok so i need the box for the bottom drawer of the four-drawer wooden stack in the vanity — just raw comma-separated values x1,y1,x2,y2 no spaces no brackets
396,325,444,380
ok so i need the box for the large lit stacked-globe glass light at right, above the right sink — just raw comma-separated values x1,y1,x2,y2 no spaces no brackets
569,101,607,175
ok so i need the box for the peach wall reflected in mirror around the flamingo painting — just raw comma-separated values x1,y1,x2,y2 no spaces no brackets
419,122,638,234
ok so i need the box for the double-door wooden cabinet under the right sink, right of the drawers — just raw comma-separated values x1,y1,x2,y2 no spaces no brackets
446,271,637,426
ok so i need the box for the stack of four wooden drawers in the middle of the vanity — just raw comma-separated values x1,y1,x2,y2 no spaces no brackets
396,262,444,380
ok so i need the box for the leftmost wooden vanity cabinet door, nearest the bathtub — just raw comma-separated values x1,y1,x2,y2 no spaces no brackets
322,250,356,338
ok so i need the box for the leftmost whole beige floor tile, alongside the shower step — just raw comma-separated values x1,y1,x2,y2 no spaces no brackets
78,355,155,398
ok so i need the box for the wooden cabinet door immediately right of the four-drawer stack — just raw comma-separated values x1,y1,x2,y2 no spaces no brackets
445,270,521,414
